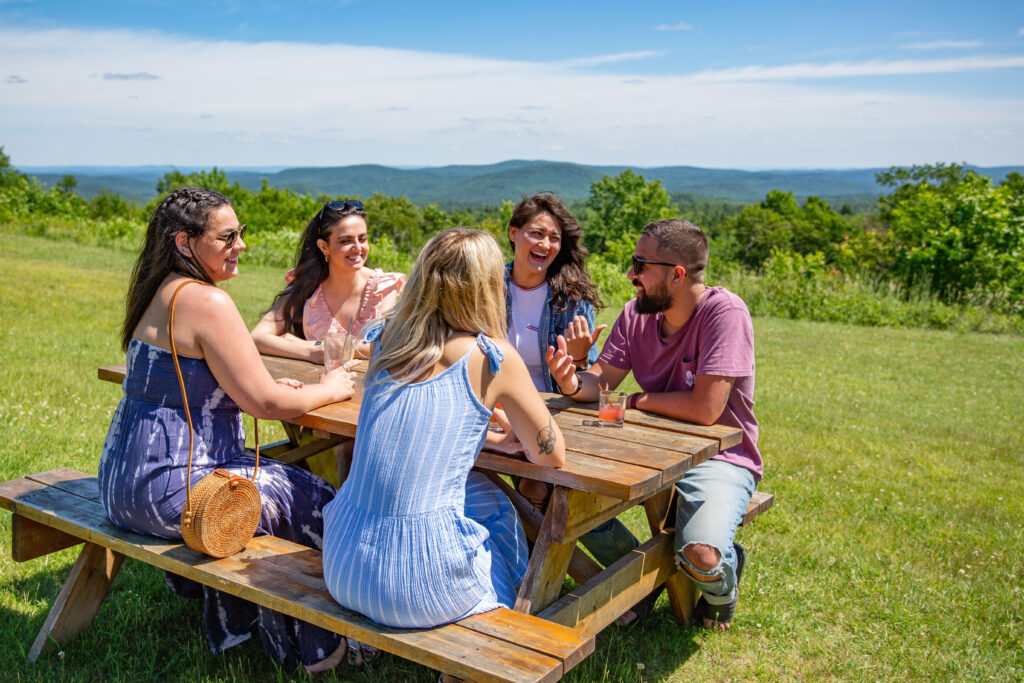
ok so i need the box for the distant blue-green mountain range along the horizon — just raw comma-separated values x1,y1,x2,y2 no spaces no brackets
20,160,1024,208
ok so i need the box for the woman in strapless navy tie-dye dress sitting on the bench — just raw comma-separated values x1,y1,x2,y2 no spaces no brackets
98,187,353,670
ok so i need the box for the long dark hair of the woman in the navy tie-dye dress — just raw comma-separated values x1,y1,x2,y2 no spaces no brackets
121,187,231,351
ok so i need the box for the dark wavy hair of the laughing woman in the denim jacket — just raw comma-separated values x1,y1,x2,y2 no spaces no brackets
509,193,604,311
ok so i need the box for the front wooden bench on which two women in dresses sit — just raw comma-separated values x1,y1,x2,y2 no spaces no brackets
0,468,594,681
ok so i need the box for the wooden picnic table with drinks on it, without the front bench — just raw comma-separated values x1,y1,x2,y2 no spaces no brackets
98,355,745,633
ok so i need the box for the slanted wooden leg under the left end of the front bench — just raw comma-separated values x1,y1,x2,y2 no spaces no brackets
27,543,125,664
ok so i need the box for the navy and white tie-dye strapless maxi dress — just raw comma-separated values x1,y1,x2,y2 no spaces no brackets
99,339,341,665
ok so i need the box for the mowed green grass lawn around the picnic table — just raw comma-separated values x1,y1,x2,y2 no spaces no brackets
0,232,1024,682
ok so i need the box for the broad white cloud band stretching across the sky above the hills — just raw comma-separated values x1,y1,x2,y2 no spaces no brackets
0,26,1024,168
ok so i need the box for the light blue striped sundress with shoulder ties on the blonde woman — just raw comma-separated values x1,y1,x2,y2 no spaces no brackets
324,328,527,628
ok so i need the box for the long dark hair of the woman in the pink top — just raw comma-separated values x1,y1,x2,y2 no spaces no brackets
271,202,367,339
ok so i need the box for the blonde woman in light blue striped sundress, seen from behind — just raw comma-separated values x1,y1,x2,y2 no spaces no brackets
324,228,565,627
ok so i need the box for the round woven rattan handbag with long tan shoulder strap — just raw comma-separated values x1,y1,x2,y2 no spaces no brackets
168,280,262,557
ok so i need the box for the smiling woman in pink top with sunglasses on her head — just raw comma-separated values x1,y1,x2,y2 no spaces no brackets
252,200,406,362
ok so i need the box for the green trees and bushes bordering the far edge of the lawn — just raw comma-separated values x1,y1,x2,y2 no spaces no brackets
0,147,1024,325
